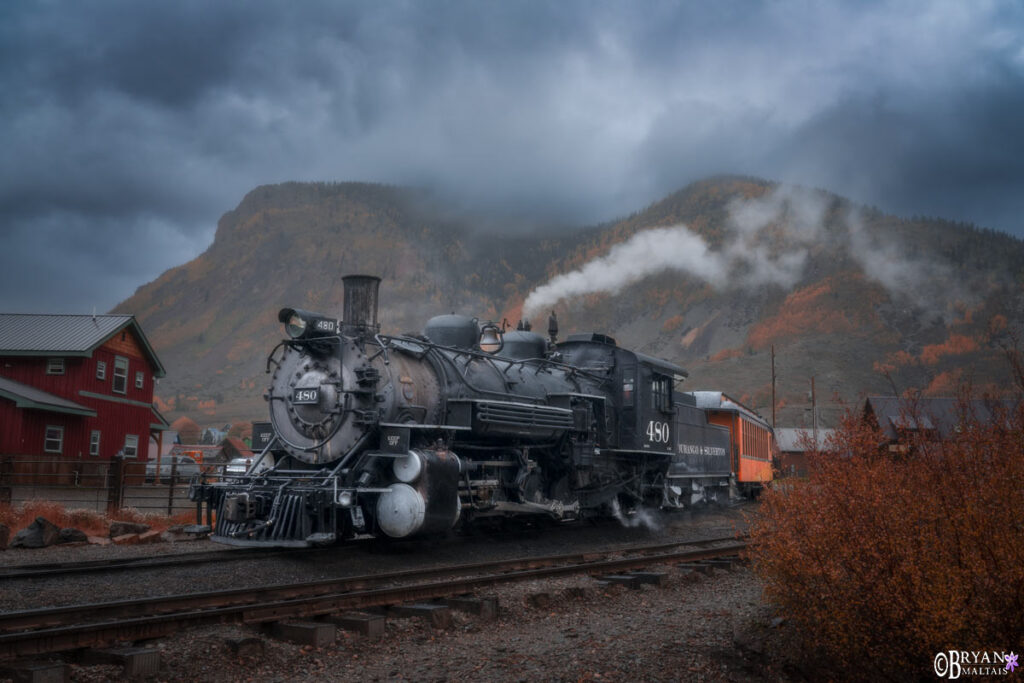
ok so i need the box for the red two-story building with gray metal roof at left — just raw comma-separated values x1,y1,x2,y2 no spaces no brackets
0,313,168,462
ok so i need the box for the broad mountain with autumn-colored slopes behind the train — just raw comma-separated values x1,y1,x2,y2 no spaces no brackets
115,177,1024,424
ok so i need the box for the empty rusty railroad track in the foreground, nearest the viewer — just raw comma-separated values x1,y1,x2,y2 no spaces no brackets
0,538,746,660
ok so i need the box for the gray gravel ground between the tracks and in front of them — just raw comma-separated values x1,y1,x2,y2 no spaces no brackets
0,508,798,681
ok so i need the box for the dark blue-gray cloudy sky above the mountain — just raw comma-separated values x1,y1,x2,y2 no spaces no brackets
0,0,1024,312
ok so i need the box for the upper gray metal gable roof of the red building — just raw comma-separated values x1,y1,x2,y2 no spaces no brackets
0,313,166,377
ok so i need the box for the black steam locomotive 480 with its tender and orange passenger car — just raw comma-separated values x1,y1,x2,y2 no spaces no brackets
190,275,771,547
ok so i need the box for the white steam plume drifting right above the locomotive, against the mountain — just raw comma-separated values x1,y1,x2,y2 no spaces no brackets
523,185,966,317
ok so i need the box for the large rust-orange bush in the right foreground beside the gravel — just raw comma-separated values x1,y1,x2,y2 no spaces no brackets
752,389,1024,680
